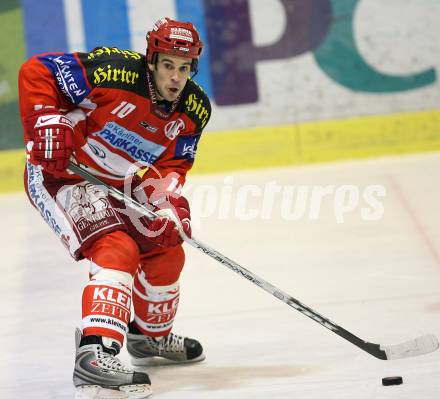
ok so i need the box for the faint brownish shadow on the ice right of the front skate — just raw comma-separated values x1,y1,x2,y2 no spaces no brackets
136,362,316,394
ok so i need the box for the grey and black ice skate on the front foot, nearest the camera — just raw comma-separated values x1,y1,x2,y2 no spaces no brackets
73,329,152,399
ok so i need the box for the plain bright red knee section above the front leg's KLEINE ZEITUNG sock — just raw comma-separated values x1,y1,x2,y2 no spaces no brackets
83,230,139,276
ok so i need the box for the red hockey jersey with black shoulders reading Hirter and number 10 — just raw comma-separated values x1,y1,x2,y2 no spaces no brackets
18,47,211,191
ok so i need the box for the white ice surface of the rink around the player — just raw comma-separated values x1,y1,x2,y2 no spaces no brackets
0,154,440,399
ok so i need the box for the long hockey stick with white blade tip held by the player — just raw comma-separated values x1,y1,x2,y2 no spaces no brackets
69,162,439,360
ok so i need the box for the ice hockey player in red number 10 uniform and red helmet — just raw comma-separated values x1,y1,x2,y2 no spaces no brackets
19,18,211,398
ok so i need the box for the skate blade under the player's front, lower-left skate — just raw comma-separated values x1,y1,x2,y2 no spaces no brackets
74,384,153,399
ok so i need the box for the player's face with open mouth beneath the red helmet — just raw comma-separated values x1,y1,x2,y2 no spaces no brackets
148,53,191,101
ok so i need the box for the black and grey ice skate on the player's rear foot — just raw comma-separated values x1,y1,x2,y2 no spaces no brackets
127,323,205,366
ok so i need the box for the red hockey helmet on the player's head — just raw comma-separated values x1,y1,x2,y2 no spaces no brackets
147,17,203,72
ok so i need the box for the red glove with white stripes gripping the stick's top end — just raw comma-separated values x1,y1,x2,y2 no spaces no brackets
26,108,73,173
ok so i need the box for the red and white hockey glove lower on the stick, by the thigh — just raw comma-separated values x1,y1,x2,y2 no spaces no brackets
147,196,191,247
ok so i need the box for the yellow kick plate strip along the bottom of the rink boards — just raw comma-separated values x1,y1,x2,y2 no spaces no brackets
0,110,440,192
